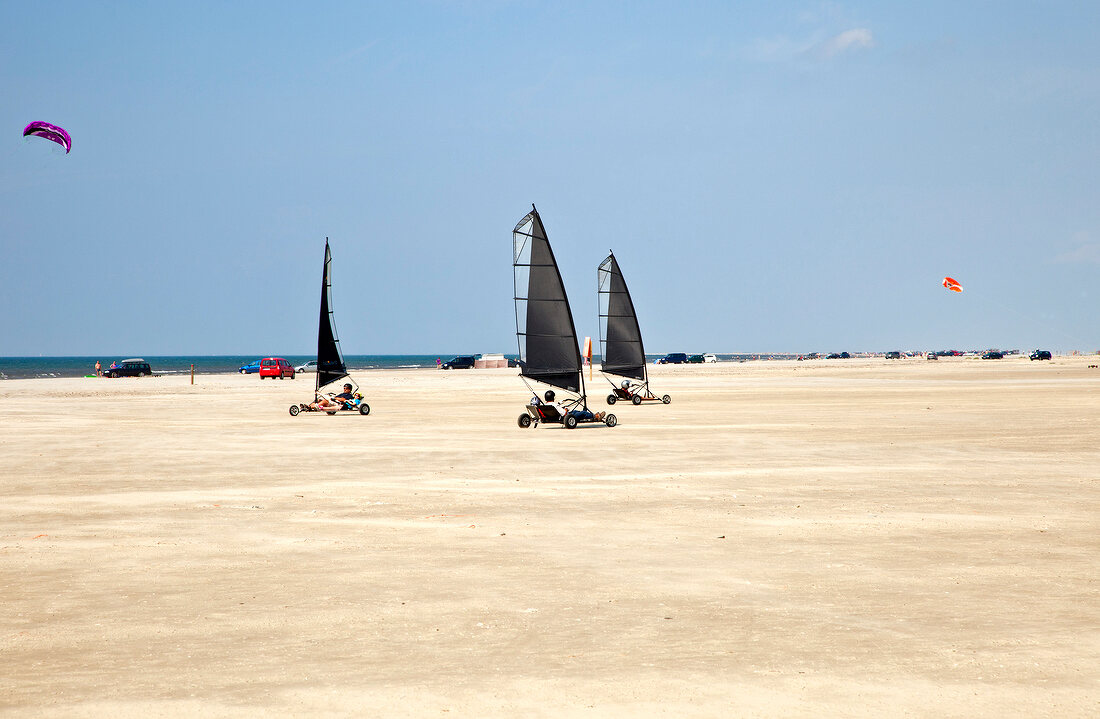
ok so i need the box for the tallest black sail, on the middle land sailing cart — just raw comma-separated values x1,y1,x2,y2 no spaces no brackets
512,206,581,394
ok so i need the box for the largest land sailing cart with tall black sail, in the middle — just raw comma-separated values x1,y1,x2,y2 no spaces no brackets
512,204,618,429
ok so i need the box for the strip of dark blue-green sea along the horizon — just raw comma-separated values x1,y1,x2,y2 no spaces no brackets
0,353,796,379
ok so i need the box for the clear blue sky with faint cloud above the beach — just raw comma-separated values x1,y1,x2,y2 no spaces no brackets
0,0,1100,356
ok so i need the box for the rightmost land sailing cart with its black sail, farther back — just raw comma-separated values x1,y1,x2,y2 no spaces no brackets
596,252,672,405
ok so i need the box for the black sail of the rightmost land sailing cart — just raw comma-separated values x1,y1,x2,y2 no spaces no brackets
596,253,646,380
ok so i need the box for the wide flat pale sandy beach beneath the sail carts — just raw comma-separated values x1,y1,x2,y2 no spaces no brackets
0,356,1100,717
